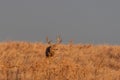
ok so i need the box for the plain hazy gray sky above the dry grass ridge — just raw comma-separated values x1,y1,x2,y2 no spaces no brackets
0,0,120,44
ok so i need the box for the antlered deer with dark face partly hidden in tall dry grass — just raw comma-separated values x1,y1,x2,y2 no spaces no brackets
45,35,62,57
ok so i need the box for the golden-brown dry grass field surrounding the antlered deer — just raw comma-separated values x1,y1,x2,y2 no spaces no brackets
0,41,120,80
